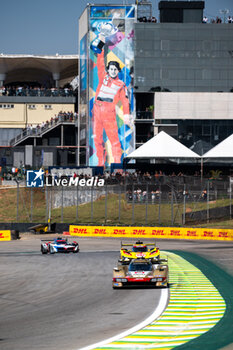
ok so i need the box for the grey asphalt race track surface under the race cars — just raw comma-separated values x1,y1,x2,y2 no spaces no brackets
0,233,233,350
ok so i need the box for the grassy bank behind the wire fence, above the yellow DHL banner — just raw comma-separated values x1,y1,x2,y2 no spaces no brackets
0,188,233,228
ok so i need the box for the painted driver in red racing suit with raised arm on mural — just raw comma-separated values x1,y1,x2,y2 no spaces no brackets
93,22,133,166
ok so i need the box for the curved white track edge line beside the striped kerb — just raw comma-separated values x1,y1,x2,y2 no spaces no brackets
77,288,169,350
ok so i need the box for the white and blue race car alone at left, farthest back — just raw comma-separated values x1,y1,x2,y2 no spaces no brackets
41,237,79,254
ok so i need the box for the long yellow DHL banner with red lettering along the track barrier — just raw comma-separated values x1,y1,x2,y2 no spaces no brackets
69,225,233,241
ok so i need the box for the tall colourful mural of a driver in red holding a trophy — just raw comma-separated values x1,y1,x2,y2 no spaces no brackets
89,6,135,166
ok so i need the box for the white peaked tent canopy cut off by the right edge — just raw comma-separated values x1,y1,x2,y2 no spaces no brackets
202,134,233,158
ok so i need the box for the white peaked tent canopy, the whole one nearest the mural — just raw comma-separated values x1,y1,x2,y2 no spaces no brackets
126,131,200,159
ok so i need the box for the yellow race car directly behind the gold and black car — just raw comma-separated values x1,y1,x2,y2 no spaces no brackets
119,241,160,264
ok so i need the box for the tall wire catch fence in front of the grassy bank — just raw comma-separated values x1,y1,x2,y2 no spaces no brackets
0,176,233,226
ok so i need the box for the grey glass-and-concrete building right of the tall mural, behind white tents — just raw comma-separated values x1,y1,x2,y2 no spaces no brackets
134,1,233,154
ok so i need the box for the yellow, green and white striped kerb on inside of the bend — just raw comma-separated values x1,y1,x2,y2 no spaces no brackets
78,252,226,350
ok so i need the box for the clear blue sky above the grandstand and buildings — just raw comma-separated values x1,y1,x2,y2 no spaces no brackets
0,0,233,55
